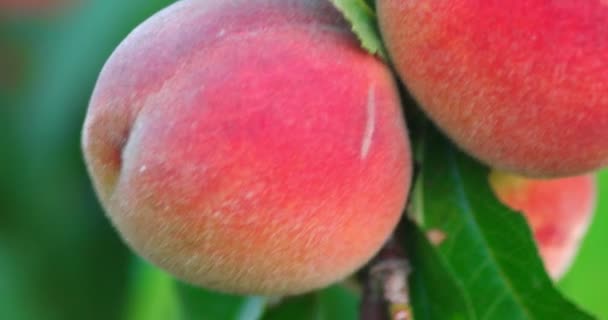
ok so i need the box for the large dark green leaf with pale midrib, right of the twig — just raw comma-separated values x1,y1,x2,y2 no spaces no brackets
414,126,592,320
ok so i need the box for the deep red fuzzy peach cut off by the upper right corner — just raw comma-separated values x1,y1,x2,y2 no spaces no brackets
377,0,608,177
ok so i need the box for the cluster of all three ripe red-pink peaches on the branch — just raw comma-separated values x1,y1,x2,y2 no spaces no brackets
83,0,608,295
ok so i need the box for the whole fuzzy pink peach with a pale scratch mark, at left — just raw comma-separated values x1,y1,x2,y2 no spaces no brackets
82,0,412,295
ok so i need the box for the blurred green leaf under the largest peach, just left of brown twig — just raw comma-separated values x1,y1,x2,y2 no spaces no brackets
263,286,359,320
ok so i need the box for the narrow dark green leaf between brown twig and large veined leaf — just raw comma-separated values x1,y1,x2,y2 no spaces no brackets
397,219,474,320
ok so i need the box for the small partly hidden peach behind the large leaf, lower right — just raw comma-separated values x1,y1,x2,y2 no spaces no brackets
490,171,596,279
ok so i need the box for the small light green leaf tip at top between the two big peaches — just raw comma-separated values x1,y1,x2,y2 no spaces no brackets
331,0,388,61
